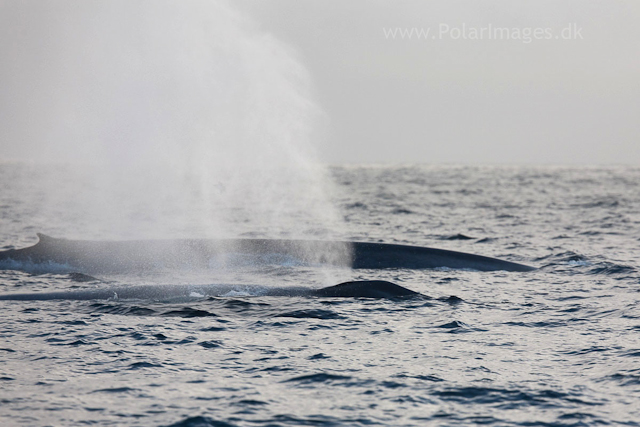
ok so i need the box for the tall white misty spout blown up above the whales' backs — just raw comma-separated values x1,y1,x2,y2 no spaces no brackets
0,0,344,280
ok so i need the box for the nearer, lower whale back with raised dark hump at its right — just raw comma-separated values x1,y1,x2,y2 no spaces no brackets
0,280,428,301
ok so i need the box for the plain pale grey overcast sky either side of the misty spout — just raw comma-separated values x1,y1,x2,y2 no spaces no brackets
0,0,640,165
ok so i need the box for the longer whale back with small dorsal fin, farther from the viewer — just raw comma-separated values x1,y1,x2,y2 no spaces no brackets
0,233,536,273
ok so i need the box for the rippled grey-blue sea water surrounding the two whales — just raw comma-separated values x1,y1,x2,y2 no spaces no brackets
0,163,640,427
